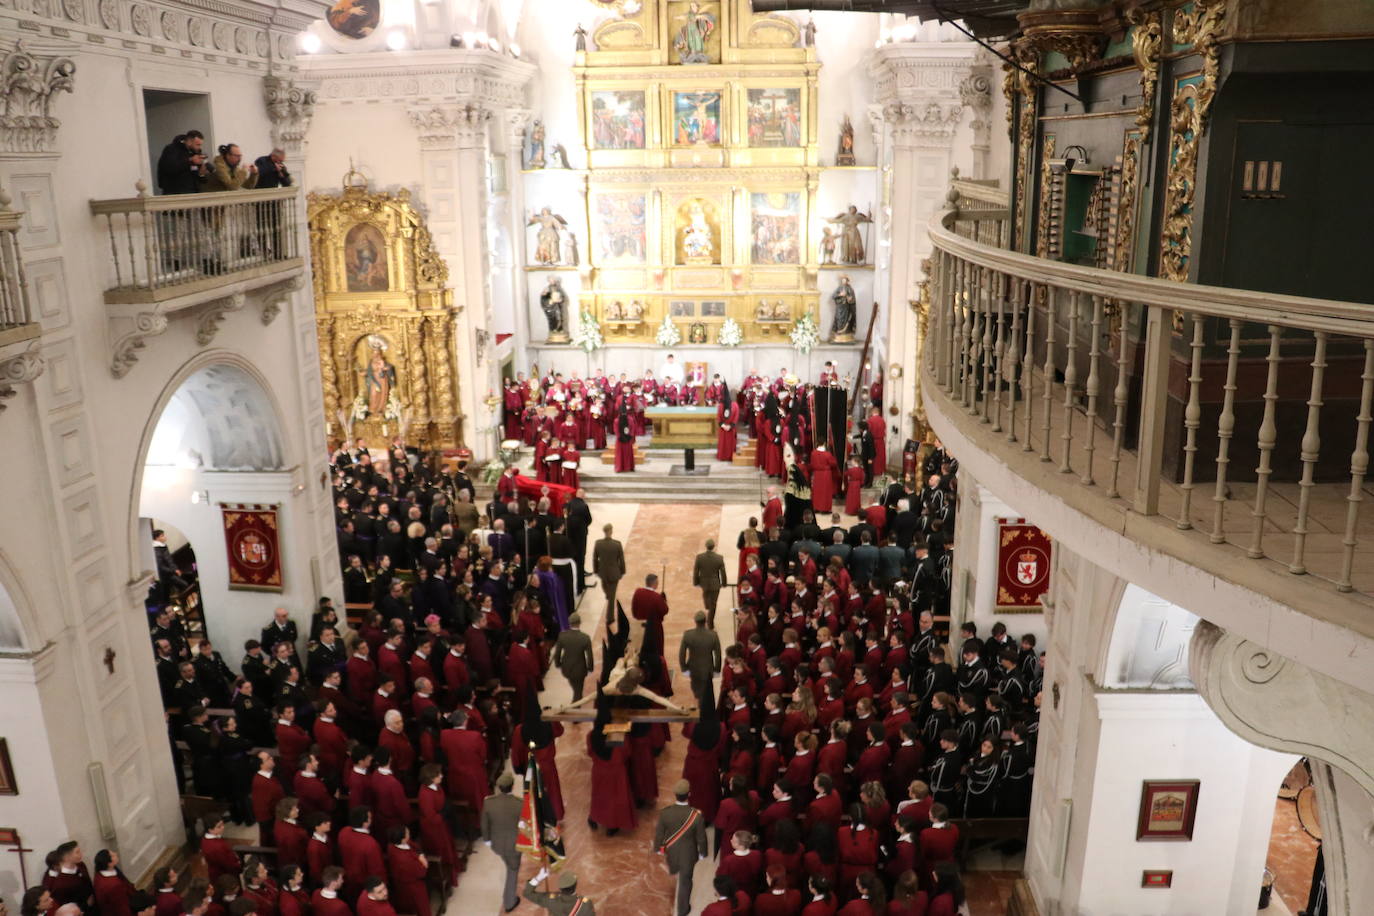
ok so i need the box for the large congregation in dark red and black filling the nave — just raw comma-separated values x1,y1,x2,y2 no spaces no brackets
32,420,1041,916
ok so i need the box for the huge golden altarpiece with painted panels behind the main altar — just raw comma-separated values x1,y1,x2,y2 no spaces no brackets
560,0,820,343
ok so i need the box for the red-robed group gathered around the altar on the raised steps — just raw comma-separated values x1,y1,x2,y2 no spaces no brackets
503,362,888,486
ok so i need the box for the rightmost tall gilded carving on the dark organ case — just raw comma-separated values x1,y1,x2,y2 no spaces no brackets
1160,0,1226,282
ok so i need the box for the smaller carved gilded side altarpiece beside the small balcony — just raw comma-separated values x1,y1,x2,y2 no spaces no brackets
308,172,463,449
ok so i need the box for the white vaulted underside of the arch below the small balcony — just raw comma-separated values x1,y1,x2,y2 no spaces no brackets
128,350,301,581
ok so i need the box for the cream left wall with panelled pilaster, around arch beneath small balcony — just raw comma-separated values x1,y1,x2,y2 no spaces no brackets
0,17,341,889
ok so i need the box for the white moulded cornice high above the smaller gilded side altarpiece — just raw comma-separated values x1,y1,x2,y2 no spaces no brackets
298,51,537,108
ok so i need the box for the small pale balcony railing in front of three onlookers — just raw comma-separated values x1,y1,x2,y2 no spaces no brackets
91,183,304,304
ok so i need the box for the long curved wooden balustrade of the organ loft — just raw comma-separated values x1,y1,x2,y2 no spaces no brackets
923,204,1374,596
